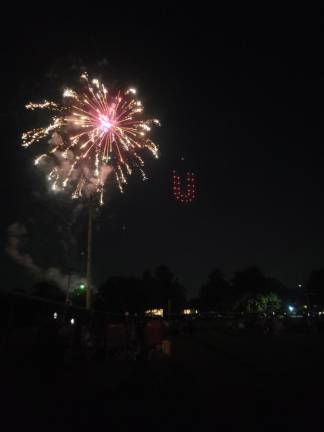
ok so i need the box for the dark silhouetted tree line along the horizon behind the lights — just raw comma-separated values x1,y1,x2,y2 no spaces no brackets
34,266,324,314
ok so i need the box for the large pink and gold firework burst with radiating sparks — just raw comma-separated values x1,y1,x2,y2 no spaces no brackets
22,74,159,203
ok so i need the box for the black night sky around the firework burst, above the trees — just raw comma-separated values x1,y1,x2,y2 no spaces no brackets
0,8,324,293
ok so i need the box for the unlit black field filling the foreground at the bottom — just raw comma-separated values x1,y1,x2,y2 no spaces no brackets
1,330,324,431
